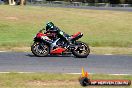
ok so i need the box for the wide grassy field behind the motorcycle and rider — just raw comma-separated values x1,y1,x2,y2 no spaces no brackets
0,5,132,47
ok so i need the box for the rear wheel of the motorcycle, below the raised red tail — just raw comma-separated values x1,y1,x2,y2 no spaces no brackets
72,41,90,58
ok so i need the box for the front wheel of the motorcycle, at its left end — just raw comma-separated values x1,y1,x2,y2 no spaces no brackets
31,42,50,57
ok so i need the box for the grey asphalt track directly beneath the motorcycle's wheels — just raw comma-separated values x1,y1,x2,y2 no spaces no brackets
0,52,132,74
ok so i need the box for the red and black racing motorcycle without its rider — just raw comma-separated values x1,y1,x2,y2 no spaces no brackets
31,29,90,58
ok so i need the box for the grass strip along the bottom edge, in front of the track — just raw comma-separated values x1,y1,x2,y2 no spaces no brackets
0,73,132,88
